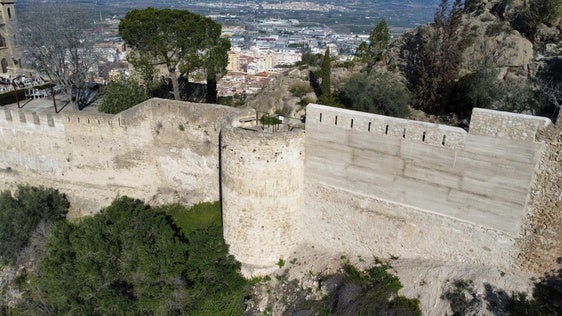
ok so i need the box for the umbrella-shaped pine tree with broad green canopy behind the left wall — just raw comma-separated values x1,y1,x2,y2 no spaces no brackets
119,7,230,100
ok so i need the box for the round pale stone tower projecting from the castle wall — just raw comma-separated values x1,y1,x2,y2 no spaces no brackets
220,116,304,276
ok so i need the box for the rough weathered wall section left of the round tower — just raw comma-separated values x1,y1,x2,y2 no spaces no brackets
0,99,238,216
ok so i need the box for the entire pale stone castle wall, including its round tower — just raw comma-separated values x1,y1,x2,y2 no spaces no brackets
0,99,562,275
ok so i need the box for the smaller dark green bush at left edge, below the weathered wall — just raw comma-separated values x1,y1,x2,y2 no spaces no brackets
0,186,70,264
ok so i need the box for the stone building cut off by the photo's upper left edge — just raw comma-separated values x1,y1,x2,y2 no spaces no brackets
0,0,20,75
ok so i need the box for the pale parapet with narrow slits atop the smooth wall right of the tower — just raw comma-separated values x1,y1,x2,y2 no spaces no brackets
306,104,467,148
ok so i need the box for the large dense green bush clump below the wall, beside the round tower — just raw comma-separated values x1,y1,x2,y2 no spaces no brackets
31,197,245,315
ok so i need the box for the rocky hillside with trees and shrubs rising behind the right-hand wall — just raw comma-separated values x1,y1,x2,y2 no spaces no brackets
260,0,562,127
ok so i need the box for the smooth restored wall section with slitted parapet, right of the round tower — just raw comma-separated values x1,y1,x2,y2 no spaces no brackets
304,105,546,266
